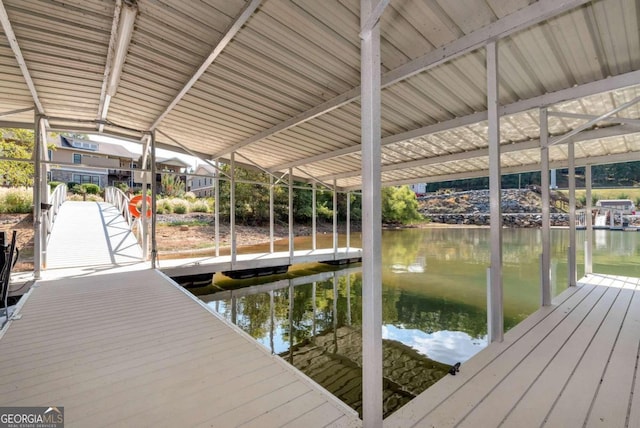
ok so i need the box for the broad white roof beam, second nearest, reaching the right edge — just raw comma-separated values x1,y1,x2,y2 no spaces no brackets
270,71,640,171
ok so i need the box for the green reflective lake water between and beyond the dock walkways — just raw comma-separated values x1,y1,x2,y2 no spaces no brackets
195,228,640,415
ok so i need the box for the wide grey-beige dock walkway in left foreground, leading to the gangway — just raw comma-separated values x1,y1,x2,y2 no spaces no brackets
0,270,361,427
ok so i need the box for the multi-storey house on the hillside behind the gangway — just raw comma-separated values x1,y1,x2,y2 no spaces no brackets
47,135,138,187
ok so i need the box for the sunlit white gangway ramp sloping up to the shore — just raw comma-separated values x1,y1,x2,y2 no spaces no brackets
46,201,142,269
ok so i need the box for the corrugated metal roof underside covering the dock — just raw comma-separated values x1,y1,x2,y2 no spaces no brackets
0,0,640,189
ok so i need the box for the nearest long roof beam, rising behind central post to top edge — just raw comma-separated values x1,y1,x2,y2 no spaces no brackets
214,0,589,157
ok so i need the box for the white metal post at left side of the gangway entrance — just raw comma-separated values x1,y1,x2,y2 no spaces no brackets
33,109,46,279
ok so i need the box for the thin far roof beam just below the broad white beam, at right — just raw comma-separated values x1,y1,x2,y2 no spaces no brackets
330,125,638,180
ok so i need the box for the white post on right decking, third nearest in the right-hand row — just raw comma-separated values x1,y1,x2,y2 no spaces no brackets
540,108,551,306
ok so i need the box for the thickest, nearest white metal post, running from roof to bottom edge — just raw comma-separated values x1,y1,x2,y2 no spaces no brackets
360,0,383,428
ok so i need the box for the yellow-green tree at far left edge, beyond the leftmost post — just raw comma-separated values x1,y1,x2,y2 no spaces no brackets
0,128,34,187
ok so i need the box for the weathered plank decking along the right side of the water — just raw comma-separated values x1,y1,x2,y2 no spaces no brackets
385,275,640,428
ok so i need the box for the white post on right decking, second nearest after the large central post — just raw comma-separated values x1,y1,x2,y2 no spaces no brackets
487,42,504,343
